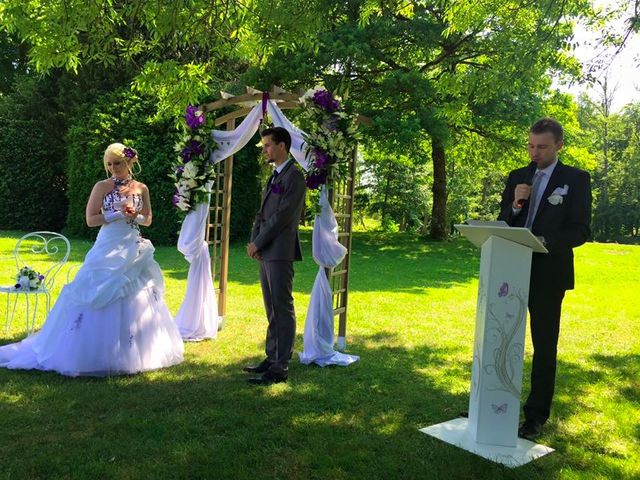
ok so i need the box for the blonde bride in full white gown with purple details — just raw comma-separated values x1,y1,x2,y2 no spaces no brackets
0,143,184,376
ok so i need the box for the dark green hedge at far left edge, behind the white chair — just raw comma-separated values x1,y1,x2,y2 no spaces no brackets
0,77,67,231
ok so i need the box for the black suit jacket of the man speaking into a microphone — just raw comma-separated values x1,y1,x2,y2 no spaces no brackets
498,161,591,290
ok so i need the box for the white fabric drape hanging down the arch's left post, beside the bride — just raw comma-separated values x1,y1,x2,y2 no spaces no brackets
175,197,220,341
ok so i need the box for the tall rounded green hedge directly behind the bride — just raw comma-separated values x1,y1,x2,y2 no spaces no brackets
65,89,179,244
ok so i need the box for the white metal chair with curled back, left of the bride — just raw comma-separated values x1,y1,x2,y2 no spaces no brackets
0,232,71,335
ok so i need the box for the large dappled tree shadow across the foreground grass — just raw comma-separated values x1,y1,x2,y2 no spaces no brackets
0,332,637,480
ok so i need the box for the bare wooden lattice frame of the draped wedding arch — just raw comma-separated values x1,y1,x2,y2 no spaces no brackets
202,86,357,348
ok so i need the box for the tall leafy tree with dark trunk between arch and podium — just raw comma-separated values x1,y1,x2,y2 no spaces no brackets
245,0,590,239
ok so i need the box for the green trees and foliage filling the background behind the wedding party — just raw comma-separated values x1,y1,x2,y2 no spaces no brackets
0,0,640,242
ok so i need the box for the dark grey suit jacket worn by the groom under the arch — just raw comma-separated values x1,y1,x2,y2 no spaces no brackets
251,160,307,261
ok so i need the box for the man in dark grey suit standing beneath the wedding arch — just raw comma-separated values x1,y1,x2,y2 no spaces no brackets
244,127,306,384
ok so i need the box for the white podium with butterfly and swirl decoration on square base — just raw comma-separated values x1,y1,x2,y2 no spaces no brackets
420,222,553,467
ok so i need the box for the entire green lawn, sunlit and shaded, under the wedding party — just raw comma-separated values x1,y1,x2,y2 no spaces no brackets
0,232,640,480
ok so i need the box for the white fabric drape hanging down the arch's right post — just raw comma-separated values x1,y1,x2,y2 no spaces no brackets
299,187,360,367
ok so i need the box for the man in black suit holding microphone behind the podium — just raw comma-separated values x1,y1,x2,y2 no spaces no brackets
499,118,591,440
